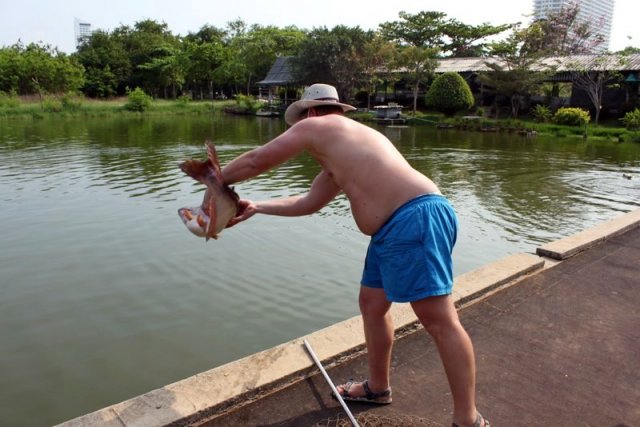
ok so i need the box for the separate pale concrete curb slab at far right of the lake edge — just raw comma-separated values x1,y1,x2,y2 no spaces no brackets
536,209,640,260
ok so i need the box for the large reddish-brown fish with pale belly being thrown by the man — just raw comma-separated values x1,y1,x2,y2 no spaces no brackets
178,141,240,241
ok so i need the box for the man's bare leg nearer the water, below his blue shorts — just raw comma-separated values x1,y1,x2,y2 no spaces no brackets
338,286,393,397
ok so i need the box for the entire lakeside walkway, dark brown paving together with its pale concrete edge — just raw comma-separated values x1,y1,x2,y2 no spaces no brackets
64,210,640,427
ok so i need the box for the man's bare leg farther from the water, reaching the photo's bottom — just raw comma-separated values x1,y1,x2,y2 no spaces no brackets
411,296,477,427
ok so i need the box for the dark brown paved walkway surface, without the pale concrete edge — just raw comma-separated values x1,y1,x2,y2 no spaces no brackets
204,219,640,427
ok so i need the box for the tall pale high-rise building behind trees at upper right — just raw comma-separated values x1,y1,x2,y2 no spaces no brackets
533,0,615,52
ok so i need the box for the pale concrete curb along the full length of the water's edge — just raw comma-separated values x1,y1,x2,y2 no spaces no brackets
59,209,640,427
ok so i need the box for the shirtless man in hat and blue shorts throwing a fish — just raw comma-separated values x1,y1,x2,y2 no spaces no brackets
222,84,489,427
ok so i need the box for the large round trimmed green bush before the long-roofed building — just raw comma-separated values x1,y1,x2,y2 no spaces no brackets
425,72,474,116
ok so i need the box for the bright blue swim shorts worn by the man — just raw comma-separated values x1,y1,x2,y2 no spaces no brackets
360,194,458,302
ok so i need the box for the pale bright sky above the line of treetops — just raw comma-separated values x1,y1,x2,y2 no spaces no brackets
0,0,640,53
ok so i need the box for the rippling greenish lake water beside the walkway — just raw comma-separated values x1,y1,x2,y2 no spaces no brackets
0,116,640,426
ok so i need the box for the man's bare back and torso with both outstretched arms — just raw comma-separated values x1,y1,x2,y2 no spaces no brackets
223,114,439,235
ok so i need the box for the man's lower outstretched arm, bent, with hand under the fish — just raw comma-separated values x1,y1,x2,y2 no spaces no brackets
228,171,340,227
